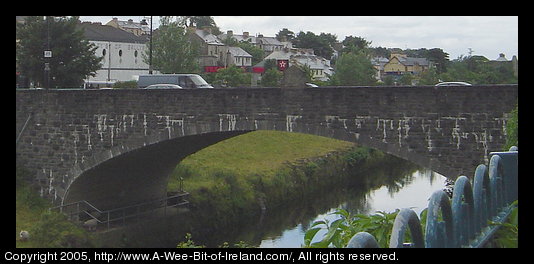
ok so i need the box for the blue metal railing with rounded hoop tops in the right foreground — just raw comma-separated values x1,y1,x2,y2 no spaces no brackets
347,146,518,248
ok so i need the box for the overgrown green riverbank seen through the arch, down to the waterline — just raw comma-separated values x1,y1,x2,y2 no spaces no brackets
168,131,418,246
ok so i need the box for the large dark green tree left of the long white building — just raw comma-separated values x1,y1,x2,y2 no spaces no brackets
16,16,102,88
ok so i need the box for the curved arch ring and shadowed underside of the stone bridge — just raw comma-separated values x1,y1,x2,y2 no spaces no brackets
62,127,447,210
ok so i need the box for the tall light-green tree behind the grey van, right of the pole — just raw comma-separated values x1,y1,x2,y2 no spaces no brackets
147,17,199,73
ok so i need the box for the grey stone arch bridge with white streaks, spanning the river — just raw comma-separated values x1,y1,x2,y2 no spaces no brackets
16,85,518,209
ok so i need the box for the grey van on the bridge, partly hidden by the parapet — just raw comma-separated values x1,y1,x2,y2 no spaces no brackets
137,74,213,88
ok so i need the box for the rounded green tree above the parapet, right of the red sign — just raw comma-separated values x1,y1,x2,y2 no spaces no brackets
332,52,376,85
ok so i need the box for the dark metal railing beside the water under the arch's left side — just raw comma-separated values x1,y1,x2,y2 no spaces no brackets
50,192,189,230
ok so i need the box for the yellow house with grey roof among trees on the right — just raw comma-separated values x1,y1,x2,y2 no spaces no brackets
384,54,430,74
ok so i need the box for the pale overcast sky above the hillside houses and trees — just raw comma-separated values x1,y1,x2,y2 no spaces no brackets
80,16,519,60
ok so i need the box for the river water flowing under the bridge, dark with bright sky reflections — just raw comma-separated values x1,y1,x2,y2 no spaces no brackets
110,157,447,248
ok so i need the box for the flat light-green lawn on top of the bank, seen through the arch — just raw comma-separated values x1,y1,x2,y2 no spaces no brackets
165,131,353,189
